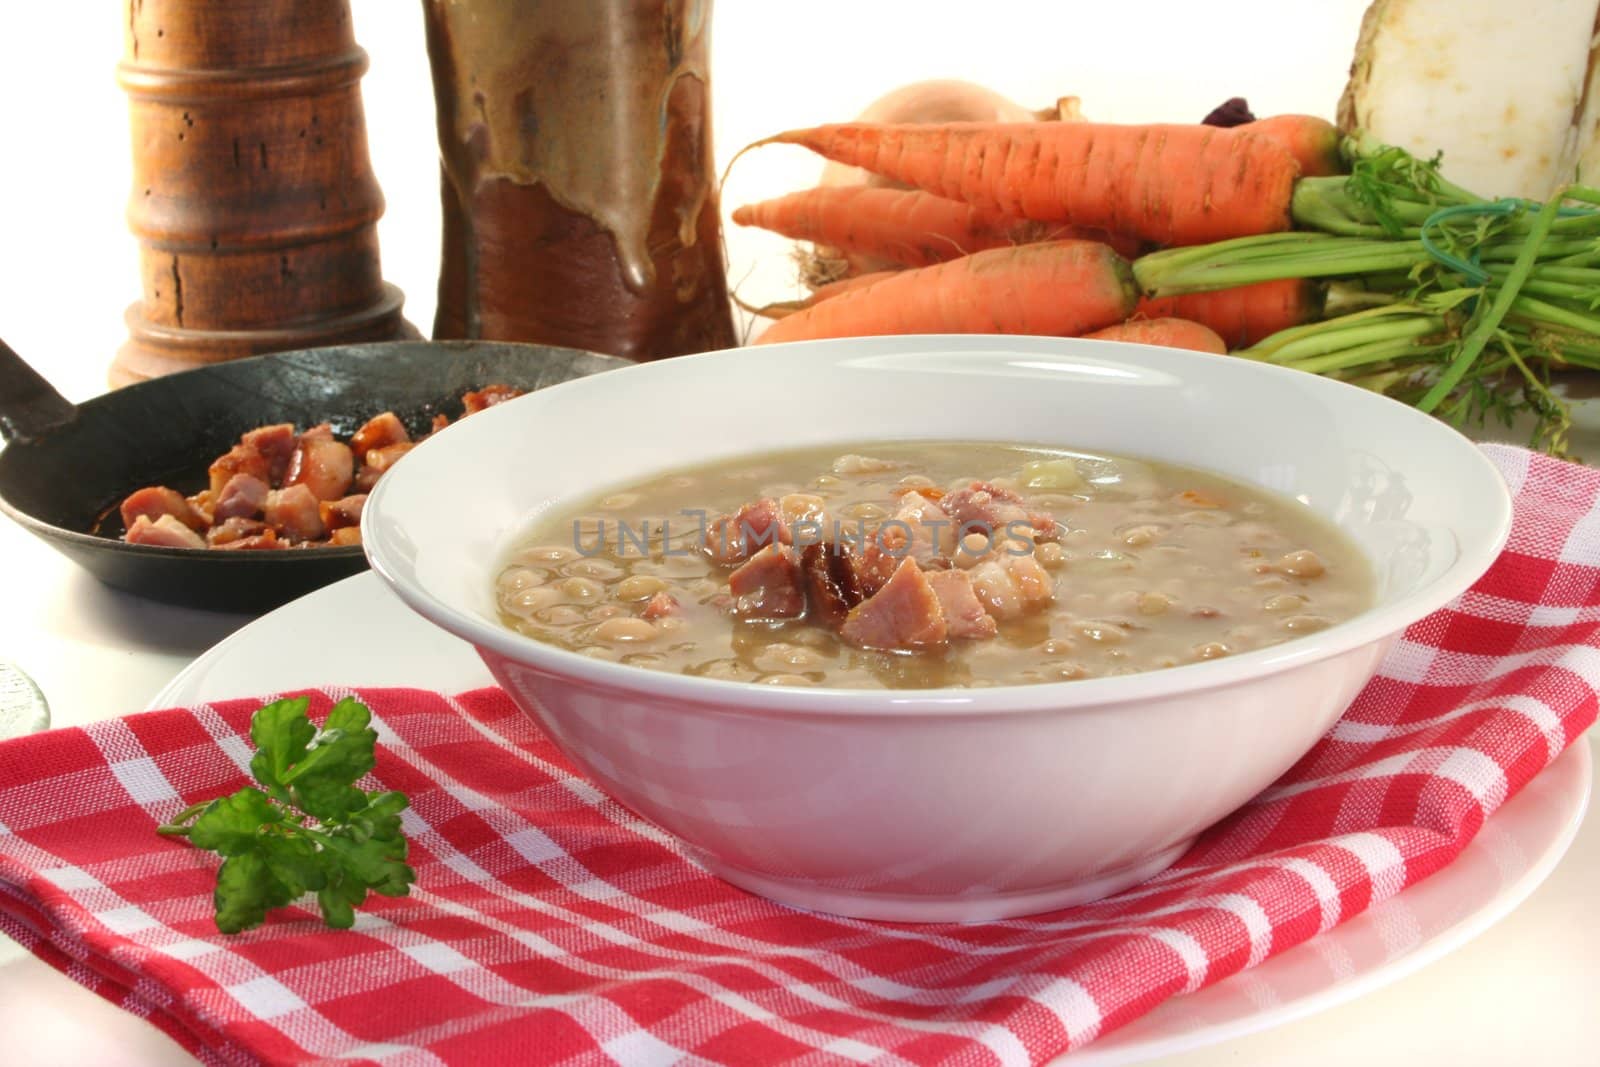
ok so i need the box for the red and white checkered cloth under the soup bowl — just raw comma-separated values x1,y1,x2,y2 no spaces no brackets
0,446,1600,1067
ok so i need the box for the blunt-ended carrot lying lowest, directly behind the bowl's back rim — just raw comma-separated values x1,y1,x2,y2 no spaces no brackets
757,242,1138,344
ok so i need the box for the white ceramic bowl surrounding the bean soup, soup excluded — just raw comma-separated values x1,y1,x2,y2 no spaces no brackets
363,336,1510,921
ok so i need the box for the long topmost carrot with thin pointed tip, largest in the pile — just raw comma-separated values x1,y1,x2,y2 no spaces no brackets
757,122,1299,245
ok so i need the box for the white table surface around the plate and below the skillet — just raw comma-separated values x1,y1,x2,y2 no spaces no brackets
0,502,1600,1067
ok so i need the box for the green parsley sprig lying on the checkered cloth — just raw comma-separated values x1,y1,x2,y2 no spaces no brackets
157,696,416,934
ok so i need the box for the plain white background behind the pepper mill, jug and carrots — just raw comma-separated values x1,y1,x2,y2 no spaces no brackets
0,0,1366,400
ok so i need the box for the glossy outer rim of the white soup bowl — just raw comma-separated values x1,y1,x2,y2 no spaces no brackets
362,334,1512,718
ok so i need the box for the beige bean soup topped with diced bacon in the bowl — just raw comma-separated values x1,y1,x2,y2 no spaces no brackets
496,442,1374,688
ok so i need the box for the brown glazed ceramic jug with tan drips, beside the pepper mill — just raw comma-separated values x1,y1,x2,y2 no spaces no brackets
422,0,734,360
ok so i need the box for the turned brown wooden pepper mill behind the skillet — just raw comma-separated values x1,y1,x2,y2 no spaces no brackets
110,0,416,386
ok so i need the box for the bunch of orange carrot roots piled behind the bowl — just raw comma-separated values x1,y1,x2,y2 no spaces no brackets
733,115,1341,352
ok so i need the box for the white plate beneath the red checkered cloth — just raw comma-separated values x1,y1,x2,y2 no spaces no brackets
150,574,1590,1067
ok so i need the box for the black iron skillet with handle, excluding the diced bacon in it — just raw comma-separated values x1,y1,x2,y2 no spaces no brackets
0,341,629,611
